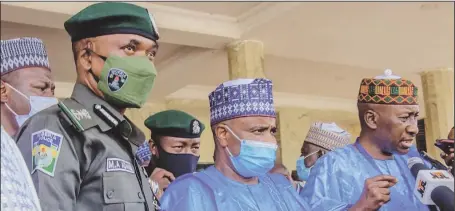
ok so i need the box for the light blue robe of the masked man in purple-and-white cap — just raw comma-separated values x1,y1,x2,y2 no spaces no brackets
160,166,310,211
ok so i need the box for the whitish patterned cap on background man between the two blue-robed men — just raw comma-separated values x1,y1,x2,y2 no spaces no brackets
305,122,351,150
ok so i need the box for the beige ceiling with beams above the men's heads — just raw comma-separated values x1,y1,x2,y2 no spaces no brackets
1,2,454,117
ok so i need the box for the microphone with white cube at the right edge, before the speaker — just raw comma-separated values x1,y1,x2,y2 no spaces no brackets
408,157,455,211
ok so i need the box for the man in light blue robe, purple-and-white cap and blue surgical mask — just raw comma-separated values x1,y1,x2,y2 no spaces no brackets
160,79,309,211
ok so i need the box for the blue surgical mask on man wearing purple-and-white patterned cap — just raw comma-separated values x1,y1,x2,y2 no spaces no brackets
226,127,278,178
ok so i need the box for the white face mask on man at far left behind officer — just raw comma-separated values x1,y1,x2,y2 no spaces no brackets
5,83,58,127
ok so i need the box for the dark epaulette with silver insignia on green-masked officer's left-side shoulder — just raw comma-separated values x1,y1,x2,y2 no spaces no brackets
58,98,97,132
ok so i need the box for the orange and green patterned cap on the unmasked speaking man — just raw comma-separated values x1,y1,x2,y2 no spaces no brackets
357,69,418,105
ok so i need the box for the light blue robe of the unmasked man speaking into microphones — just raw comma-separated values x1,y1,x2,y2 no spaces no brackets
300,141,429,211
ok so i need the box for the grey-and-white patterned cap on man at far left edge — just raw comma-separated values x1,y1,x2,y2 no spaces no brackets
1,37,51,75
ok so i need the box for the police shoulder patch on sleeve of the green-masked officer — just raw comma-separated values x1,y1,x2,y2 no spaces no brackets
31,129,63,177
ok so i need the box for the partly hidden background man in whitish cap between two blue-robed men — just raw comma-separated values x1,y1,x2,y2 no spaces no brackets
296,122,351,186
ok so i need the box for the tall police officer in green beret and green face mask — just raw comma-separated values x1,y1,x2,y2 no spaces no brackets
17,2,158,211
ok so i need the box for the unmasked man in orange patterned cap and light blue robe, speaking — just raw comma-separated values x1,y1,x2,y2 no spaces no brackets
300,71,428,211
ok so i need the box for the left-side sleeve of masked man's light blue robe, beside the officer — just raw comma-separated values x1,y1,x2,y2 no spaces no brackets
160,177,217,211
